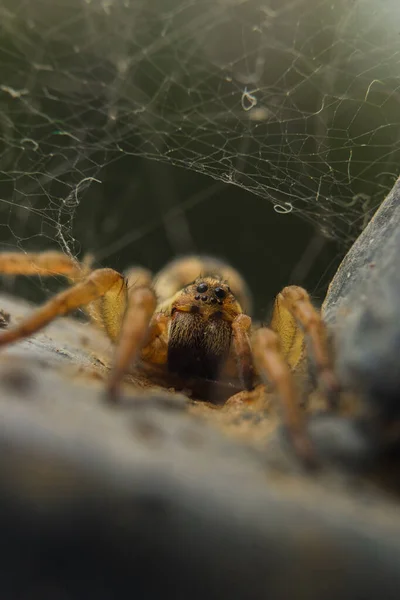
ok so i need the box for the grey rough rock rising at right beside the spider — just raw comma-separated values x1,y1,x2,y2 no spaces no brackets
324,180,400,454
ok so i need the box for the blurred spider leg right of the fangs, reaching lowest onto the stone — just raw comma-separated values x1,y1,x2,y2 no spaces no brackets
253,327,318,467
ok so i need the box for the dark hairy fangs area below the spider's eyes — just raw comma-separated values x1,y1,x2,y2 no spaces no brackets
168,312,232,379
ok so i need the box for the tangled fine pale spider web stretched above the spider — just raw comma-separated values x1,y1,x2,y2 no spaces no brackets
0,0,400,262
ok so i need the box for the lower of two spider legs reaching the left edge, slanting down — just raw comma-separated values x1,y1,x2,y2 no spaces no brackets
0,269,126,346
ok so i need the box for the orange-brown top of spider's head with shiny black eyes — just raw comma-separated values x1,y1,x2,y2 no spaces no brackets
173,276,242,321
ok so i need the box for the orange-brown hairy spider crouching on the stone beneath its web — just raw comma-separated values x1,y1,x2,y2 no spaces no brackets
0,252,338,465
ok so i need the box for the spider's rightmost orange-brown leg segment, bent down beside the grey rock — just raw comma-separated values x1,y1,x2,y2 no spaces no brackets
278,285,340,408
